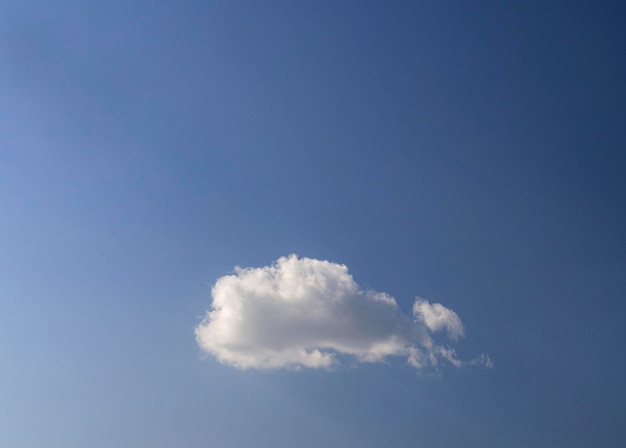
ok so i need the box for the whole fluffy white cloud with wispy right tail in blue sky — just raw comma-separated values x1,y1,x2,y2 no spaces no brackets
195,255,491,369
